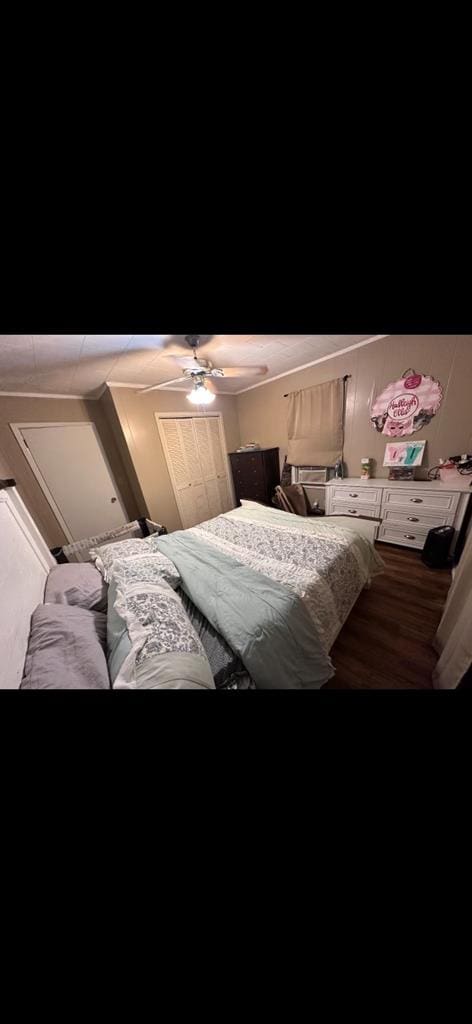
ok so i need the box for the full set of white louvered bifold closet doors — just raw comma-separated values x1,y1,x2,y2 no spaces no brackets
158,416,232,529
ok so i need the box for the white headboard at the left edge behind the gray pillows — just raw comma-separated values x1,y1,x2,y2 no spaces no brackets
0,480,55,690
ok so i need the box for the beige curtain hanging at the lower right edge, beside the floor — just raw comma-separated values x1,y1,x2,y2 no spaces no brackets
433,528,472,689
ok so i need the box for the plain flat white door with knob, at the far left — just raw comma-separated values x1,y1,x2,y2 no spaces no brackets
15,423,127,541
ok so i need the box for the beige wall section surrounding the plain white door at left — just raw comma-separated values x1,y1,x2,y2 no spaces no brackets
0,397,138,548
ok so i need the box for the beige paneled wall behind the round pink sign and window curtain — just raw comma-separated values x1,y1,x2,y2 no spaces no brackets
238,335,472,477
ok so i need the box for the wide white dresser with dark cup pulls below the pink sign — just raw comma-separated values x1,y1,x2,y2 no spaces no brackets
326,476,472,551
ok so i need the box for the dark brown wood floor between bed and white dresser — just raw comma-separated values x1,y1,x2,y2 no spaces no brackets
325,544,450,689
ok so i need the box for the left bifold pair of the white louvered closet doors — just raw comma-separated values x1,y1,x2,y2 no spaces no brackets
159,419,211,529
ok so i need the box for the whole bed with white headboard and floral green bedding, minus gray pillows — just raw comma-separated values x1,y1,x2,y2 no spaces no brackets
0,481,383,689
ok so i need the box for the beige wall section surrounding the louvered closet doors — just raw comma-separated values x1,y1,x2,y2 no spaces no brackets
106,388,240,531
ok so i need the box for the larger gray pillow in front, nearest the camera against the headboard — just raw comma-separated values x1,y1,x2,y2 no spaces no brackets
19,604,111,690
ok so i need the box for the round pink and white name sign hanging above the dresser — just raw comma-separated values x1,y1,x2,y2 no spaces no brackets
371,370,442,437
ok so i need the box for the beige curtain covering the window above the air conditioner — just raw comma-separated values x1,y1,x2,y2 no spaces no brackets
287,377,344,466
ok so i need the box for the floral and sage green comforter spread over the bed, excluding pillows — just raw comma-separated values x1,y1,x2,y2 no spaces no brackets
155,502,384,689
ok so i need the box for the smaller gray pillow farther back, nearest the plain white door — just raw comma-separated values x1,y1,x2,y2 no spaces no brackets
44,562,108,612
